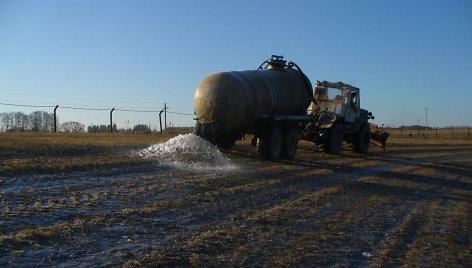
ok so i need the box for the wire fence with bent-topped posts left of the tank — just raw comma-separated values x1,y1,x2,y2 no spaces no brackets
0,102,194,132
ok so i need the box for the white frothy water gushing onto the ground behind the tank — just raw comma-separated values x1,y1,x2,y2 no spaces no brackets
138,134,236,171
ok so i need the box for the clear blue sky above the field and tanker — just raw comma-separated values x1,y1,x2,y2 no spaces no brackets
0,0,472,128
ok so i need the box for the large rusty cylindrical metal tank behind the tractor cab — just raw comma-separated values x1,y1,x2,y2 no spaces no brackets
194,56,313,144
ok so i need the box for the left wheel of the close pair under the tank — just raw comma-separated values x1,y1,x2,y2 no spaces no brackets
257,126,283,161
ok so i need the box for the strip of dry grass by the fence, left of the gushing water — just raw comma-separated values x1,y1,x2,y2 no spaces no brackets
0,133,172,174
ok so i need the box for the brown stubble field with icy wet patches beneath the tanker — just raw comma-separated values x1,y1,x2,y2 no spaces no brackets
0,133,472,267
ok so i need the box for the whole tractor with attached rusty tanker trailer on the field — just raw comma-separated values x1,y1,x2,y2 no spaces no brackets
194,55,388,161
